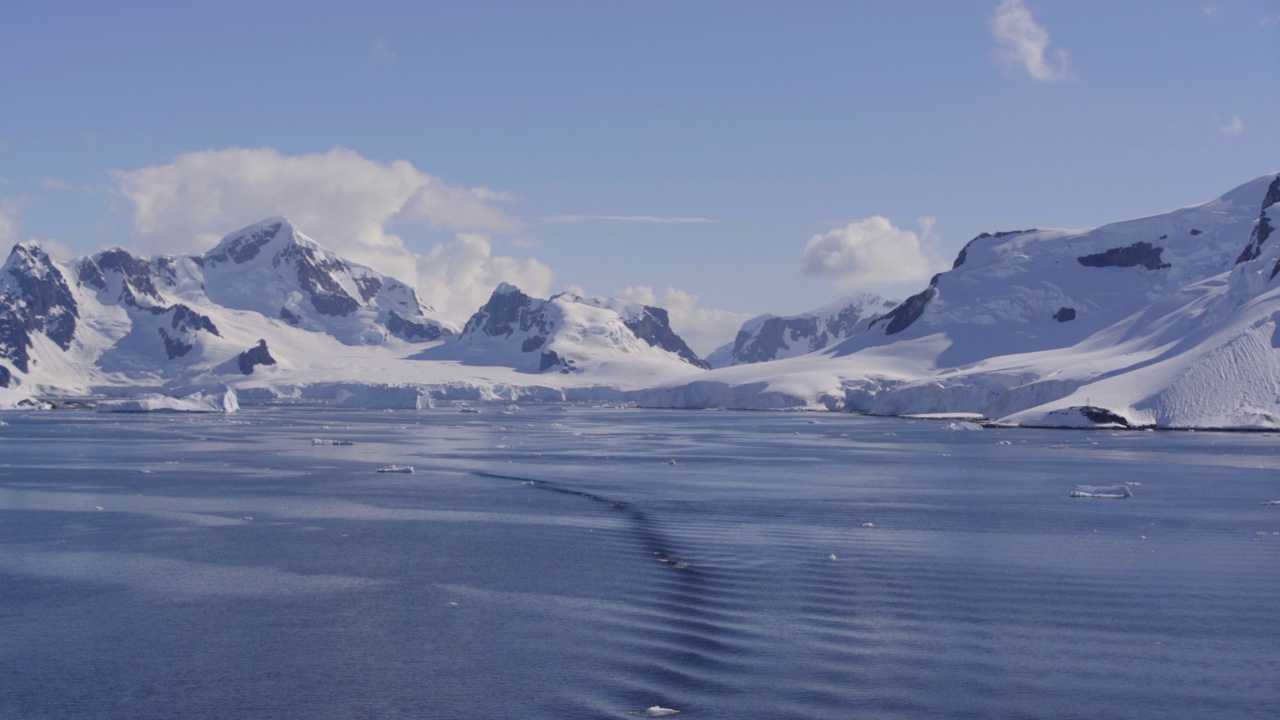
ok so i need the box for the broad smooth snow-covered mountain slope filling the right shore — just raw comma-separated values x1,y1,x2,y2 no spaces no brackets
643,174,1280,428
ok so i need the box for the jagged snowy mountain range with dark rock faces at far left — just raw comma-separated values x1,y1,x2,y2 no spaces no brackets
0,218,456,392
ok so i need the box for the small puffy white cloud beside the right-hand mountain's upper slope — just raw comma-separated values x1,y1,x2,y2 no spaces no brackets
804,215,946,290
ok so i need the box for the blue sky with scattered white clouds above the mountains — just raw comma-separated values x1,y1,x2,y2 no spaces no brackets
0,0,1280,351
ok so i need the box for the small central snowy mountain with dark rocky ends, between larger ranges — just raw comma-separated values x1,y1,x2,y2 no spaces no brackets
419,283,707,377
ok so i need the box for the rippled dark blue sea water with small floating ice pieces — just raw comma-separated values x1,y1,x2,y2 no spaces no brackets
0,405,1280,720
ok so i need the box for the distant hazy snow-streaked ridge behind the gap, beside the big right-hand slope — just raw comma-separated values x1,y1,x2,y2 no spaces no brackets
707,292,897,368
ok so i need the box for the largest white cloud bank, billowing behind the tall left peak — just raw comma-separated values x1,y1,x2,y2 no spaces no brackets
111,147,552,320
